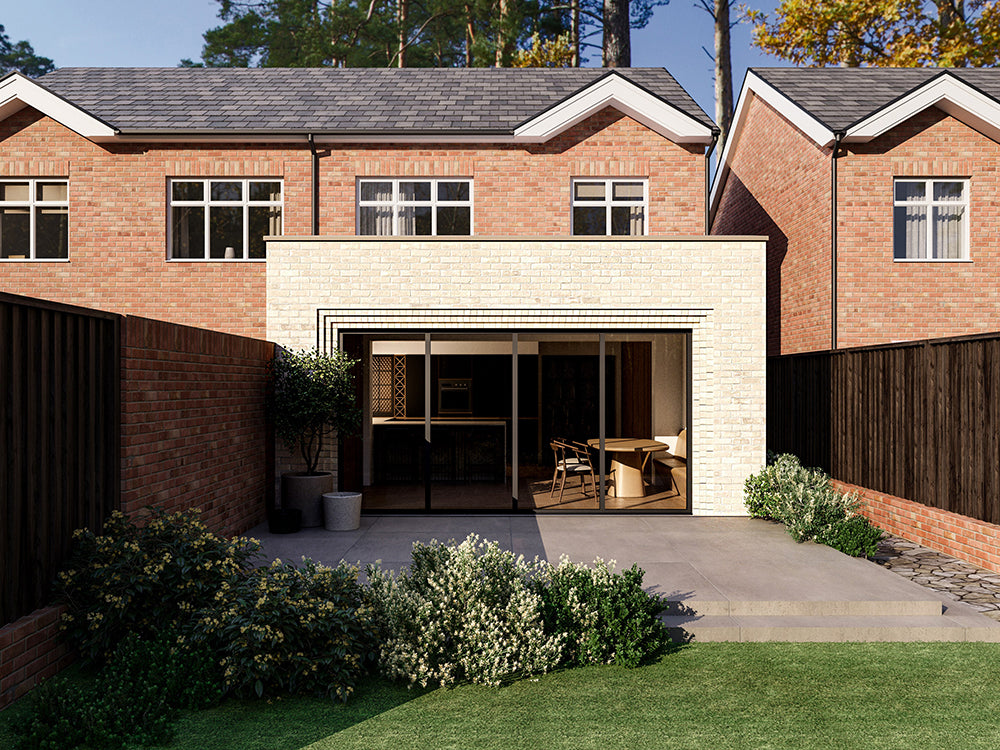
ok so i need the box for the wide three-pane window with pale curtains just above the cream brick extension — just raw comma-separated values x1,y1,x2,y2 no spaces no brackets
358,179,472,236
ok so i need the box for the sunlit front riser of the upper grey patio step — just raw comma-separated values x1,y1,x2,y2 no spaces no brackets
664,595,942,617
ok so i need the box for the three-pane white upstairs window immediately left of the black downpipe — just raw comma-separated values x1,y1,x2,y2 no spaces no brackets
169,179,282,260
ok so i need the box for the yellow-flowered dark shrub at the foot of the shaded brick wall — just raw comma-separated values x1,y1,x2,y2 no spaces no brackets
56,509,260,662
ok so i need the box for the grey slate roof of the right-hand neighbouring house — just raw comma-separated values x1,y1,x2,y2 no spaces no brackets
751,68,1000,131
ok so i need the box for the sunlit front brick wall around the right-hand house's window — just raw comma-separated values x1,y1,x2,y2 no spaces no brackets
837,108,1000,347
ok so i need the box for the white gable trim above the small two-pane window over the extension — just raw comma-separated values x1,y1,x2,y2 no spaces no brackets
514,73,712,144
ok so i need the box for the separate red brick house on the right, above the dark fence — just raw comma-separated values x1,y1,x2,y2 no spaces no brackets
711,68,1000,355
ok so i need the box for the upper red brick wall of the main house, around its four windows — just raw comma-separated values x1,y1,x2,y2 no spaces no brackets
0,109,705,337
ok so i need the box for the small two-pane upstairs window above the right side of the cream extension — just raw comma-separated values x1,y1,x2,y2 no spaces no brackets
573,179,649,235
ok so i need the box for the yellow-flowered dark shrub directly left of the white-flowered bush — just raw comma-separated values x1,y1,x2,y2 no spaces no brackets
195,560,374,700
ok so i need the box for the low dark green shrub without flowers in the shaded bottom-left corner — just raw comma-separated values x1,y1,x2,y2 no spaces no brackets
15,633,222,750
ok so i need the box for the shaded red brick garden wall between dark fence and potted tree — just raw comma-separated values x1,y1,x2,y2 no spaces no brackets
121,317,273,536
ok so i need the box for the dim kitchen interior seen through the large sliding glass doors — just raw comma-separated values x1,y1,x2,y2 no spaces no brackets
352,331,690,512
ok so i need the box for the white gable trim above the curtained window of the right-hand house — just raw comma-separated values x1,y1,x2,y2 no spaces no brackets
844,73,1000,143
